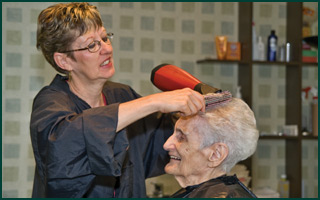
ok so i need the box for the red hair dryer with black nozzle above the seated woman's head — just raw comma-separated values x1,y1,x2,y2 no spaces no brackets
151,64,221,94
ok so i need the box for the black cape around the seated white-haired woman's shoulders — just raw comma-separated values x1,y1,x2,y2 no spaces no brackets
171,175,257,198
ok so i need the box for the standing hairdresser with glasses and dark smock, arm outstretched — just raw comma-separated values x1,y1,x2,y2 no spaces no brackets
30,3,205,198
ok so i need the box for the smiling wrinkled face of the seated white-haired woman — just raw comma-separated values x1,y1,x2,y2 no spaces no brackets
163,116,208,183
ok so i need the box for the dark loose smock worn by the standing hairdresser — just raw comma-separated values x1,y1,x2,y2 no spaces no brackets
30,75,174,198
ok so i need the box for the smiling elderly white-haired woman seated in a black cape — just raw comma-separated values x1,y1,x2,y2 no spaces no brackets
164,94,259,198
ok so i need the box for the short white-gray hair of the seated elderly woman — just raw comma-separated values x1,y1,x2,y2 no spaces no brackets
198,98,259,172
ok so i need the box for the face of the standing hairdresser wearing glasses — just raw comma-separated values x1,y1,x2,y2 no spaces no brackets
67,27,115,82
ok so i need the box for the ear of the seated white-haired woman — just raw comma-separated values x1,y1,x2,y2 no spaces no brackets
208,143,229,168
